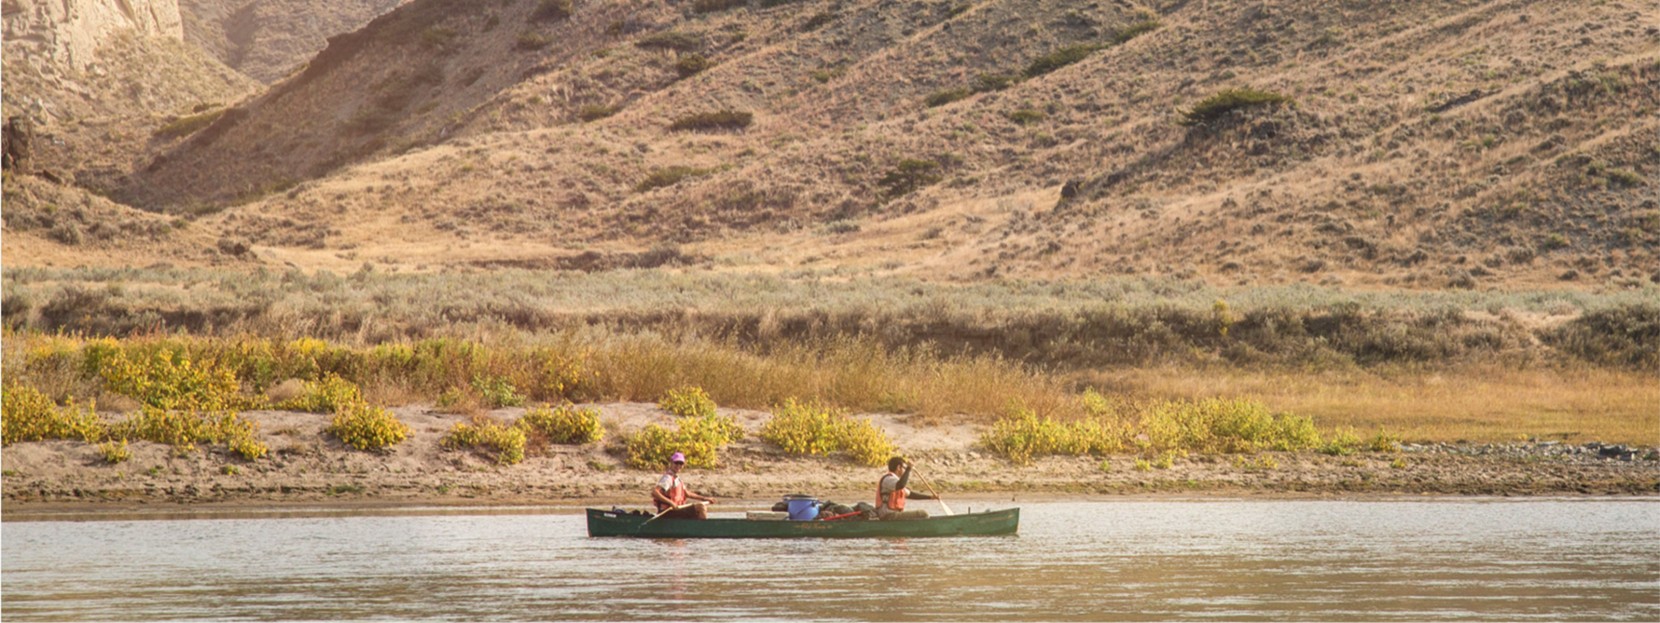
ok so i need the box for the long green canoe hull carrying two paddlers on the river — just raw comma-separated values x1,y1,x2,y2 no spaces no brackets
588,508,1021,538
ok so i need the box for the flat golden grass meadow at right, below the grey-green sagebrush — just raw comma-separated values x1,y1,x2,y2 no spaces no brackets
1089,367,1660,445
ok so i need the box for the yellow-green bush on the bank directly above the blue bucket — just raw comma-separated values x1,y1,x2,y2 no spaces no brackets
760,397,895,467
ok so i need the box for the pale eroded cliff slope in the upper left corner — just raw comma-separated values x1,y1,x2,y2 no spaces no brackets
0,0,256,182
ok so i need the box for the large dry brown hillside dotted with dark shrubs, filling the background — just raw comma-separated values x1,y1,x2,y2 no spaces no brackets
8,0,1660,289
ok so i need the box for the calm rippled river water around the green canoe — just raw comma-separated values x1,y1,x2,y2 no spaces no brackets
0,498,1660,621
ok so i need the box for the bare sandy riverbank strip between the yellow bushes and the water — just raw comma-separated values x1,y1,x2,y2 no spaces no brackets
0,404,1660,517
